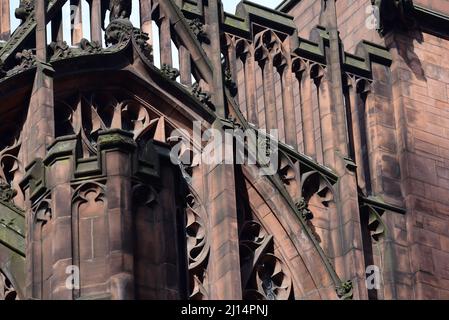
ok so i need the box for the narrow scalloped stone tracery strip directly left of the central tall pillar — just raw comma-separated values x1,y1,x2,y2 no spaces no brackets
186,193,210,300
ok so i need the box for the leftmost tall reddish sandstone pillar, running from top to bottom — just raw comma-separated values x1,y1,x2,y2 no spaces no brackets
21,1,54,298
